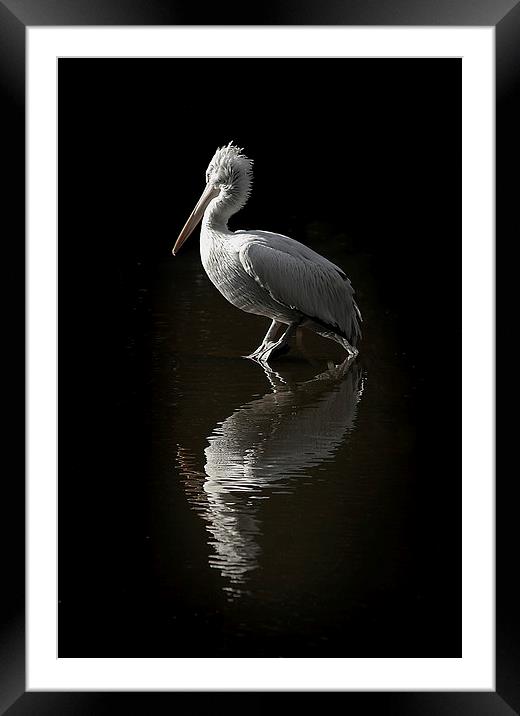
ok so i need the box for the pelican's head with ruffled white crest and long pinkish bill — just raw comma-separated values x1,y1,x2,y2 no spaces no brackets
172,142,253,256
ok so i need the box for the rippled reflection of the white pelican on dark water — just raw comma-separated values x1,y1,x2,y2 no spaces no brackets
178,360,362,595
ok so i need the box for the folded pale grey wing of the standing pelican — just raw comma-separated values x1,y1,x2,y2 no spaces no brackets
239,231,361,345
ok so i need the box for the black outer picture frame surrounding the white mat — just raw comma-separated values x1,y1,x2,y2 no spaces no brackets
4,0,508,716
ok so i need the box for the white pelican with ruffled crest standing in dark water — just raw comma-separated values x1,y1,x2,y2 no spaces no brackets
172,142,361,365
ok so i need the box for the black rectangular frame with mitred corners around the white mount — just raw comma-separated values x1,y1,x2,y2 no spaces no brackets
0,2,508,714
